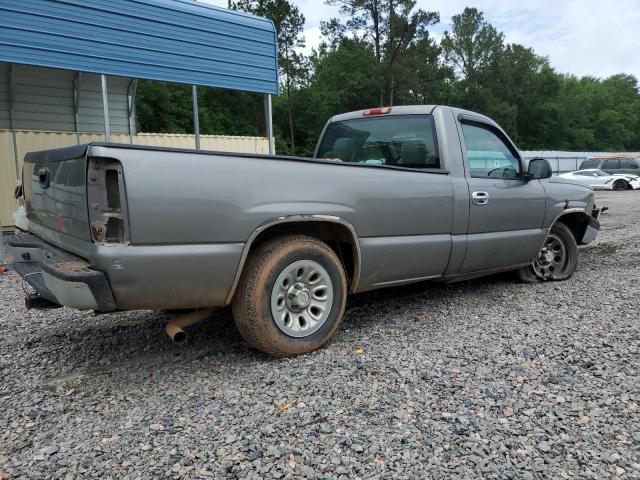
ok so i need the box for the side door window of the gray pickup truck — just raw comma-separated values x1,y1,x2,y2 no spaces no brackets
462,123,520,178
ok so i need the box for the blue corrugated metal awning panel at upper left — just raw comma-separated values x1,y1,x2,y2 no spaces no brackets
0,0,278,94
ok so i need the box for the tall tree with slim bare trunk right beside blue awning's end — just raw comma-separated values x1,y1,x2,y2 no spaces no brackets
229,0,307,152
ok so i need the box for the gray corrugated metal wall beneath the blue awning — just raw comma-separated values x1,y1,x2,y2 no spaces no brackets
0,62,135,133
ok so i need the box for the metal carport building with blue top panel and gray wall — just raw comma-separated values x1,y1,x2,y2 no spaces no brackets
0,0,278,161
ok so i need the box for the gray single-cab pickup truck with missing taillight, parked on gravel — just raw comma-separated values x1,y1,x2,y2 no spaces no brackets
7,106,599,356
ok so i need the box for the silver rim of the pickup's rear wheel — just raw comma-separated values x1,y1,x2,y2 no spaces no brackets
271,260,333,338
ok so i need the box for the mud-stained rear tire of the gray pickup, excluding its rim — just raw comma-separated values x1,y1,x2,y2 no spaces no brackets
232,235,347,357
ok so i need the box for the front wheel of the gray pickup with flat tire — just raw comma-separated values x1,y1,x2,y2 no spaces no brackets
518,222,578,283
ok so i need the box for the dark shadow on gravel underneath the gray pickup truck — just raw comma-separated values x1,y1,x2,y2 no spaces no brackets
40,275,513,386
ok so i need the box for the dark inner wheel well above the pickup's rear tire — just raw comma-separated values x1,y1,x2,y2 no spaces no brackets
249,221,360,292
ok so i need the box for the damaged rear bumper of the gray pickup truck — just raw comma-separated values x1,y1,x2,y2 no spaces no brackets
5,233,116,312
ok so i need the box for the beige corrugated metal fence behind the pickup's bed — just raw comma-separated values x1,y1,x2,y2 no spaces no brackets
0,130,269,227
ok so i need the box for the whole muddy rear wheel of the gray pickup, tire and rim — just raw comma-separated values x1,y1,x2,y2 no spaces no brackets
232,235,347,357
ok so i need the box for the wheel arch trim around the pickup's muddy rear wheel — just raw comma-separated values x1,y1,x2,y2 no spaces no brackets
226,215,362,304
